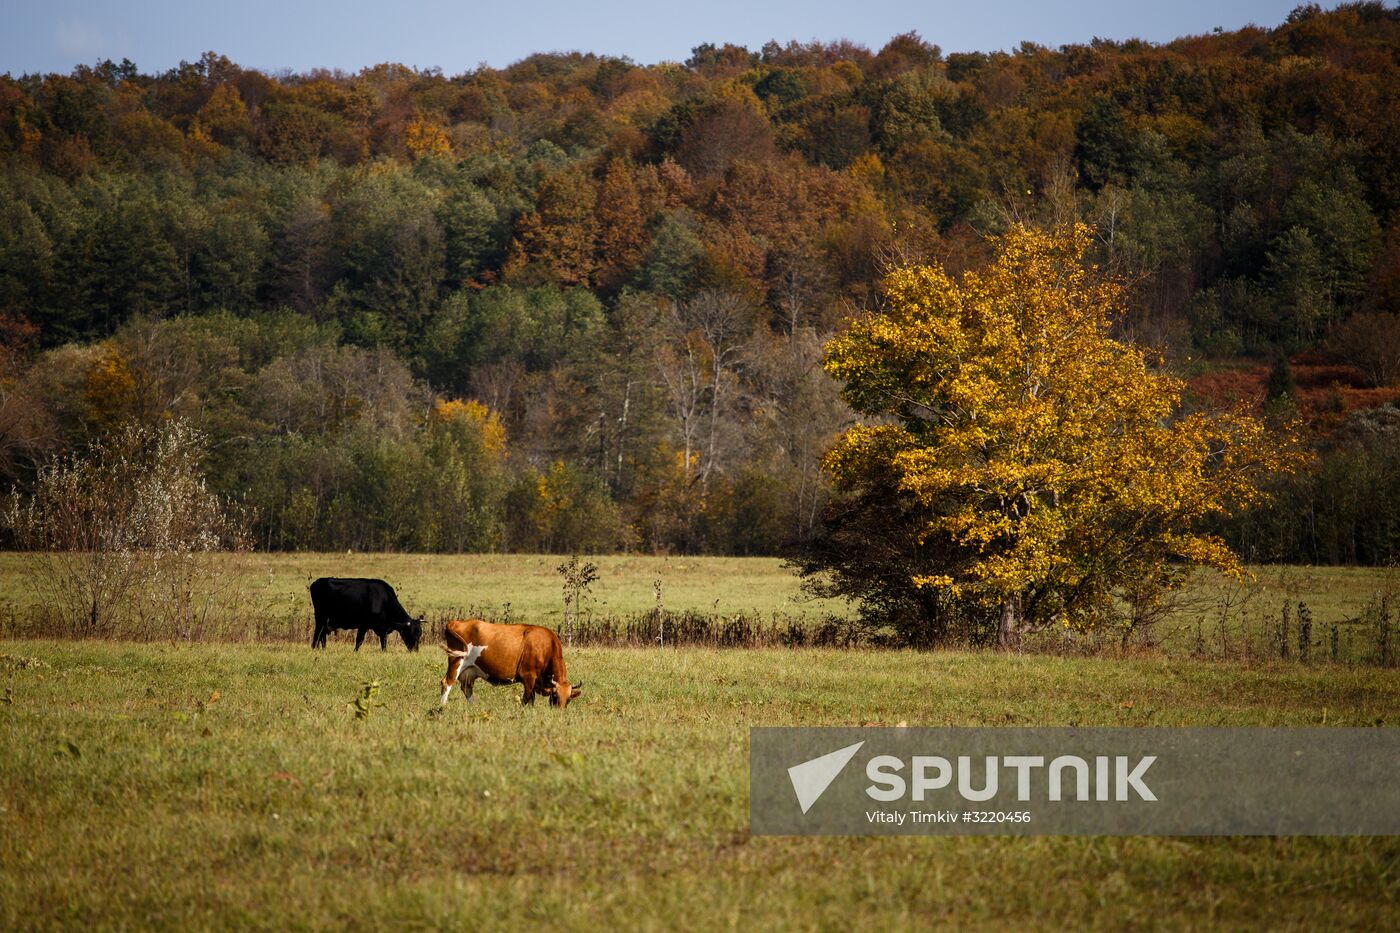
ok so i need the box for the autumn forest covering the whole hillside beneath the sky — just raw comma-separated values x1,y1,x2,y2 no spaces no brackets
0,3,1400,562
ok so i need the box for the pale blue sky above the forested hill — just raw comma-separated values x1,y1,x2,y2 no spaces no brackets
0,0,1310,74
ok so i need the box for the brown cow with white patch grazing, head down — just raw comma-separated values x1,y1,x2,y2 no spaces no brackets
442,619,584,707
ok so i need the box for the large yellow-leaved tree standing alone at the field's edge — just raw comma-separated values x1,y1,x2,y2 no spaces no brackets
825,226,1301,647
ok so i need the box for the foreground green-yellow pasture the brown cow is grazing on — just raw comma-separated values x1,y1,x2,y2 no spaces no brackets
0,644,1400,930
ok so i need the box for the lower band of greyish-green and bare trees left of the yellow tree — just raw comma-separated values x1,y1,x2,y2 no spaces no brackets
4,305,840,553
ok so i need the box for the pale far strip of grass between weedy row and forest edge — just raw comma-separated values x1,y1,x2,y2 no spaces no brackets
0,552,1400,663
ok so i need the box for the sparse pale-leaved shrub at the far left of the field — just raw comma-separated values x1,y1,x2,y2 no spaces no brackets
4,420,249,639
